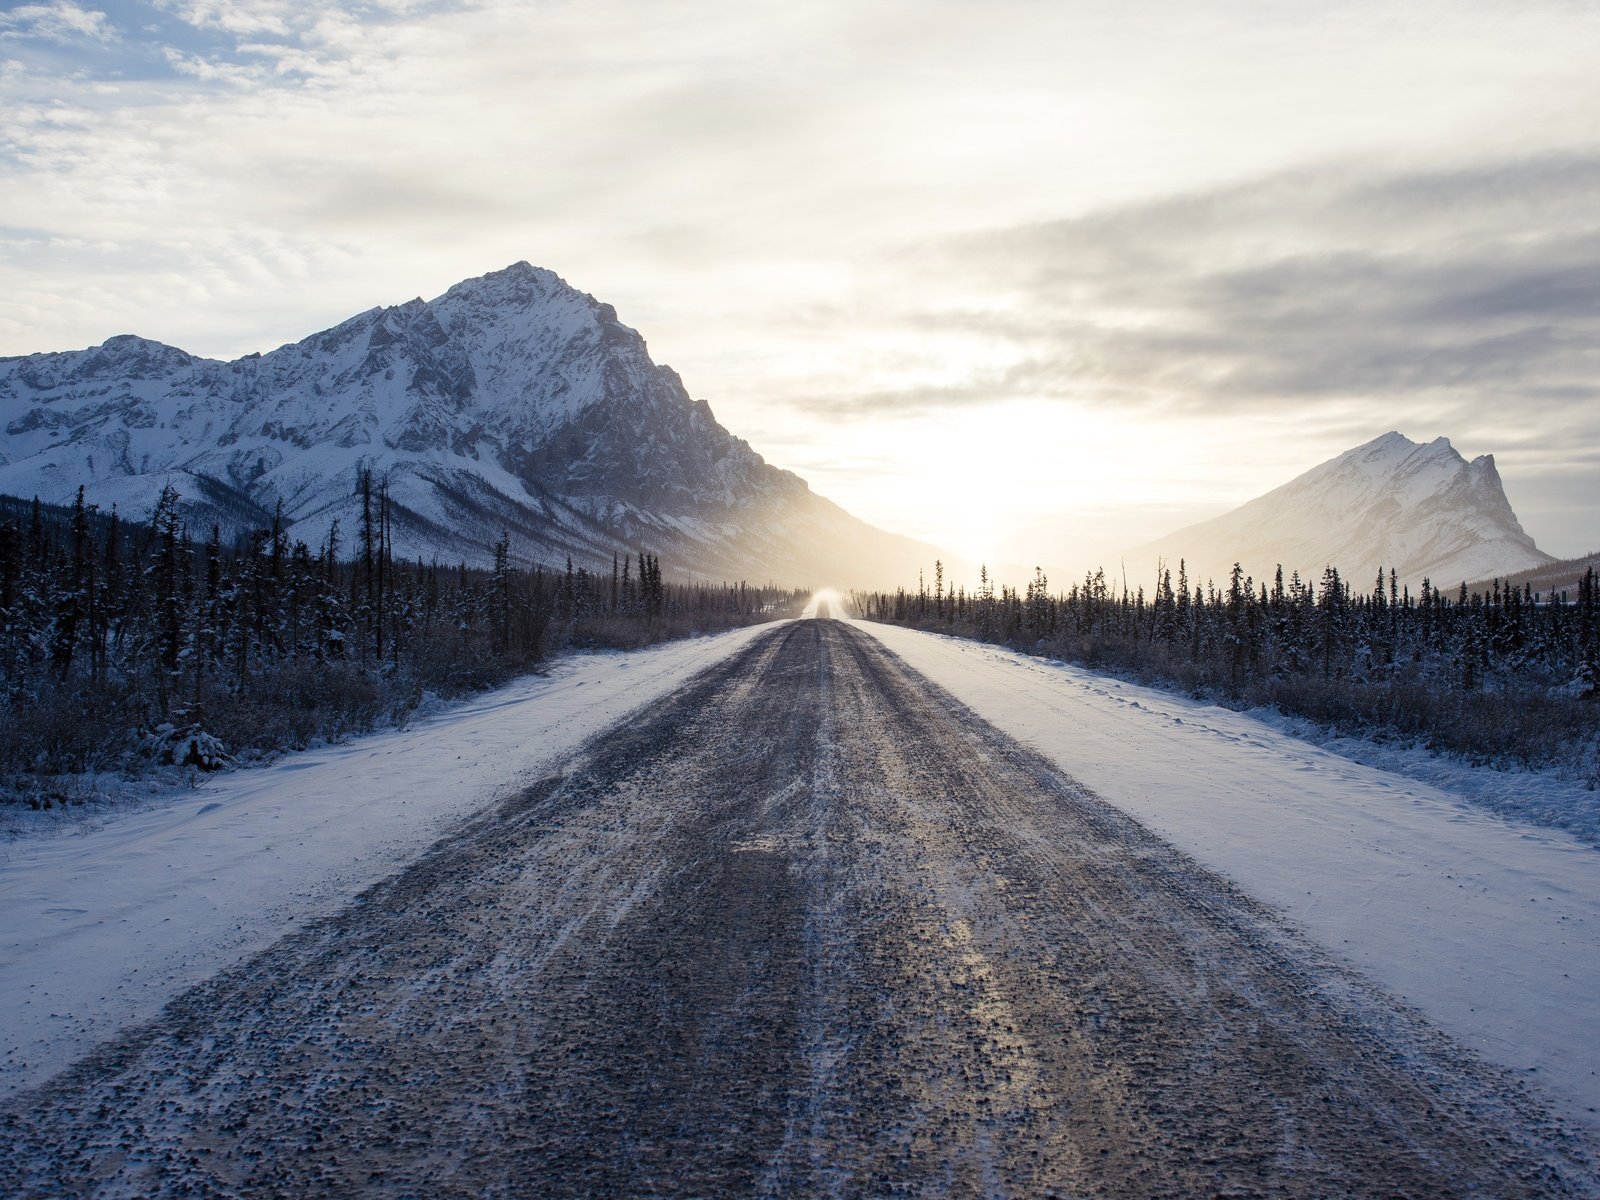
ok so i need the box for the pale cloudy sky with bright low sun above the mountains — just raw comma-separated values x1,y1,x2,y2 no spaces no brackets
0,0,1600,568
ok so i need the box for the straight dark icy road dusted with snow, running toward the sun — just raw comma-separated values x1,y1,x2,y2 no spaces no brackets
0,619,1597,1197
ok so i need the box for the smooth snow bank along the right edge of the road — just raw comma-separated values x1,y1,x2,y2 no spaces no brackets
858,621,1600,1133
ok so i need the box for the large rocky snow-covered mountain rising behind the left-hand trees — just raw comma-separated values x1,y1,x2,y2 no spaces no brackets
0,262,934,584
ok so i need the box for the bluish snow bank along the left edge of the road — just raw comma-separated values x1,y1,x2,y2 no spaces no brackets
0,626,773,1094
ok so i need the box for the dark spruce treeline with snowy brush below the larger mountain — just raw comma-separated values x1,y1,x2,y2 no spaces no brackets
0,474,803,806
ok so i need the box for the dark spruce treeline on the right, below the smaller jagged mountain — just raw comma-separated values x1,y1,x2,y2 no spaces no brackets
851,562,1600,786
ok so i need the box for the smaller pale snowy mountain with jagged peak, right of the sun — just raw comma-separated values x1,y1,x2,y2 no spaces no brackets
1128,434,1554,590
